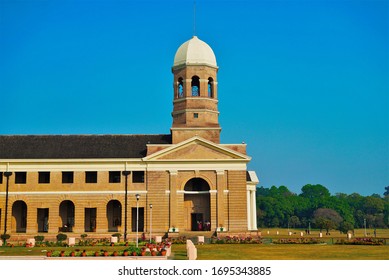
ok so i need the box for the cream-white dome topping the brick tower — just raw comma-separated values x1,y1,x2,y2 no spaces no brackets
173,36,217,67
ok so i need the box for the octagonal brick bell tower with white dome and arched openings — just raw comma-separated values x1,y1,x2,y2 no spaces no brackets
171,36,221,144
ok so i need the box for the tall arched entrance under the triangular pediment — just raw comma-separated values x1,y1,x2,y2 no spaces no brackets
184,178,211,231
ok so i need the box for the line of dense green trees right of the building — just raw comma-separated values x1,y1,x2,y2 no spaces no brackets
256,185,389,232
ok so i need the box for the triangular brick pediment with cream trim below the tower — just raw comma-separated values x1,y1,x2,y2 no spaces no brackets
144,136,250,161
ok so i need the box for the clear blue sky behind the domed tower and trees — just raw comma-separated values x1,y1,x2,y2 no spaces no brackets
0,0,389,195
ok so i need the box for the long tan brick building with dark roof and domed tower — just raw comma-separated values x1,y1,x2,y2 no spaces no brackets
0,37,258,240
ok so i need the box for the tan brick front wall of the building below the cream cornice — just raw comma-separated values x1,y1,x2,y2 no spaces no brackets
0,162,247,234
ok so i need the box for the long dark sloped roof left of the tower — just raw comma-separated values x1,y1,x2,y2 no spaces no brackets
0,134,171,159
